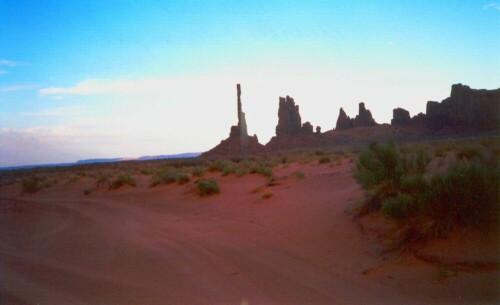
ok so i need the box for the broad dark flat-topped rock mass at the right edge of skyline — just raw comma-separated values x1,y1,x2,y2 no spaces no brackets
426,84,500,128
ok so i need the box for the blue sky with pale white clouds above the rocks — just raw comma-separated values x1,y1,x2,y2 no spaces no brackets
0,0,500,167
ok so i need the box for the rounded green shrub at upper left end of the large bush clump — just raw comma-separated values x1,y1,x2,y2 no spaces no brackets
354,142,402,189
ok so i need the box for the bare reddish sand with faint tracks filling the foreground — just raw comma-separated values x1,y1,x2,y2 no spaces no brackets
0,160,500,305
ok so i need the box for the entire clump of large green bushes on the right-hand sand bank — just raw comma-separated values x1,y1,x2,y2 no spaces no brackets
354,142,500,234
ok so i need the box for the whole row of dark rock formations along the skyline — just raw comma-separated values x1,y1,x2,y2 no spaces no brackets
204,84,500,156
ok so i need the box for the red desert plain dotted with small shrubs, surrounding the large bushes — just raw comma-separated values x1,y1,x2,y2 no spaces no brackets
0,129,500,304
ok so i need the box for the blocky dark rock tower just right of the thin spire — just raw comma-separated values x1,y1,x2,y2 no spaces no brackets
276,95,302,136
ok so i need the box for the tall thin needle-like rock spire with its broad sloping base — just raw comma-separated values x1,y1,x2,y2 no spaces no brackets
203,84,264,156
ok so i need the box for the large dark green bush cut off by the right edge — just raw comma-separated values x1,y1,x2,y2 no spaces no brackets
426,161,500,231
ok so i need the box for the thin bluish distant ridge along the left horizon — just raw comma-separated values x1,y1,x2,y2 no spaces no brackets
0,152,201,170
